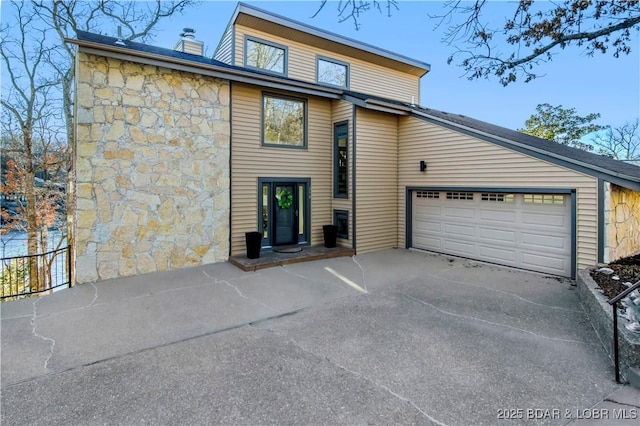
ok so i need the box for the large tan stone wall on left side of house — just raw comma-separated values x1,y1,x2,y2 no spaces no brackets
76,53,230,283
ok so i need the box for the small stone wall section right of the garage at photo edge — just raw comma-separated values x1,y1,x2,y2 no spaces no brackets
604,182,640,263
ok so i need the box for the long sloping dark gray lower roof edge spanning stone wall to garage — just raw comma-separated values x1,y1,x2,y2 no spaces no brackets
68,31,640,191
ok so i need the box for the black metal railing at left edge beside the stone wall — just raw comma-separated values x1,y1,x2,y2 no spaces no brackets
0,246,71,301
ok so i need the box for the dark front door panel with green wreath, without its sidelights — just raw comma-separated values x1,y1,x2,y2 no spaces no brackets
272,183,298,246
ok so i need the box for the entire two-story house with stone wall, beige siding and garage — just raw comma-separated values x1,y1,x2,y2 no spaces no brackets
69,4,640,282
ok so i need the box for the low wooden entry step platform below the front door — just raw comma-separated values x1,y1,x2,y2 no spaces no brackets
229,246,354,272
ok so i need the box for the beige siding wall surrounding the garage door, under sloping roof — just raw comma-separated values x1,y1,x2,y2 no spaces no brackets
400,117,598,268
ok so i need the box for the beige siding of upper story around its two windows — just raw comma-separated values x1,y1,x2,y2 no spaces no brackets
235,25,420,103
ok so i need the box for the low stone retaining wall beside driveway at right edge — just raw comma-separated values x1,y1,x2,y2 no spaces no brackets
577,270,640,377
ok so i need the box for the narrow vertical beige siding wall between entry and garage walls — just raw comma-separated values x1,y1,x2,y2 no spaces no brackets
356,108,398,253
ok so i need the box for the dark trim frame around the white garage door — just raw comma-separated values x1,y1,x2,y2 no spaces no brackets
405,186,577,280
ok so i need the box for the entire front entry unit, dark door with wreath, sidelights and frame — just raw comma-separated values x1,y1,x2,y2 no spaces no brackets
258,178,311,247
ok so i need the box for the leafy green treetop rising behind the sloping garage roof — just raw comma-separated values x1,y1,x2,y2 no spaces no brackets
519,103,605,151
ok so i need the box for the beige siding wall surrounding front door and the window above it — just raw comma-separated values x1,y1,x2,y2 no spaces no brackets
231,83,333,255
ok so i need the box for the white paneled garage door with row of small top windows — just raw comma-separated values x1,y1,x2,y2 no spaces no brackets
411,191,572,277
